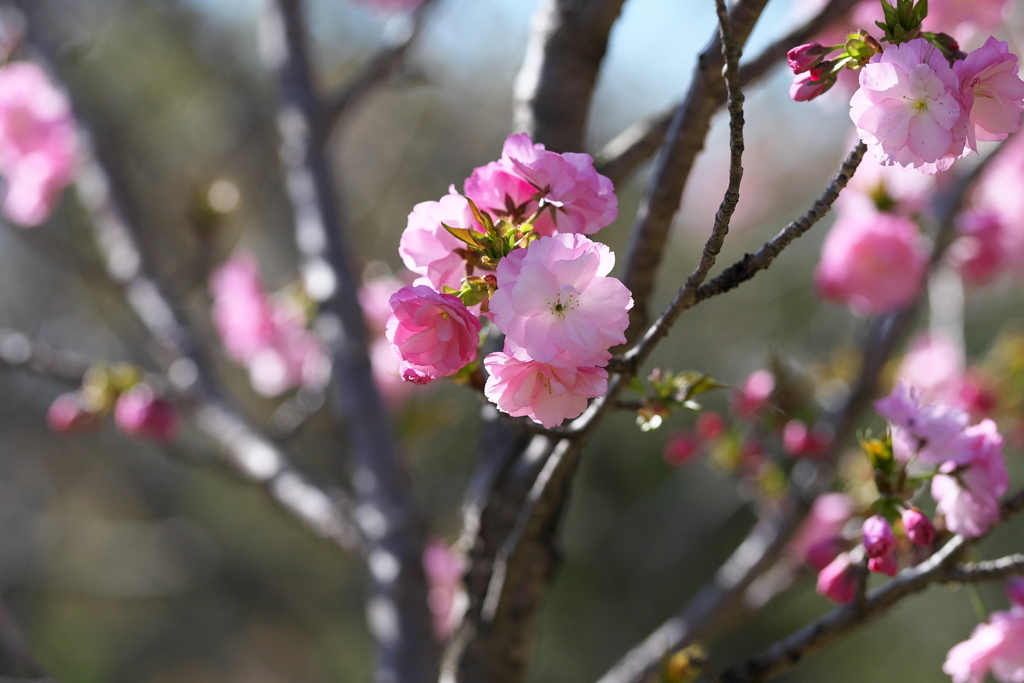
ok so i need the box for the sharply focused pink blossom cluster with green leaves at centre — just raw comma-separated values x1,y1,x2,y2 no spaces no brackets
386,134,633,427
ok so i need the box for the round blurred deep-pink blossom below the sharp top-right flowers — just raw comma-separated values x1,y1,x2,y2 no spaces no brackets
814,213,928,315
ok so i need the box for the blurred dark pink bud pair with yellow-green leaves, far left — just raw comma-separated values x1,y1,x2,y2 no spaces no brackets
46,362,180,441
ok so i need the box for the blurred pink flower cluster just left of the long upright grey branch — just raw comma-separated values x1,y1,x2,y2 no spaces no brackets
210,252,330,396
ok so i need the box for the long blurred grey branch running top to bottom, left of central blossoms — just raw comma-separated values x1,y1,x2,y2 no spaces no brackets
262,0,437,683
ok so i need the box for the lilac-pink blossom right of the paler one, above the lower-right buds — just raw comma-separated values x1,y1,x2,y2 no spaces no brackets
932,420,1010,538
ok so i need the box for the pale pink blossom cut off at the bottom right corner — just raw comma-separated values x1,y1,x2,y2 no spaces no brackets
942,605,1024,683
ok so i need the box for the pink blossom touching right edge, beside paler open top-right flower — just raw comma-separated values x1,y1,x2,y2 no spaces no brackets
953,37,1024,151
